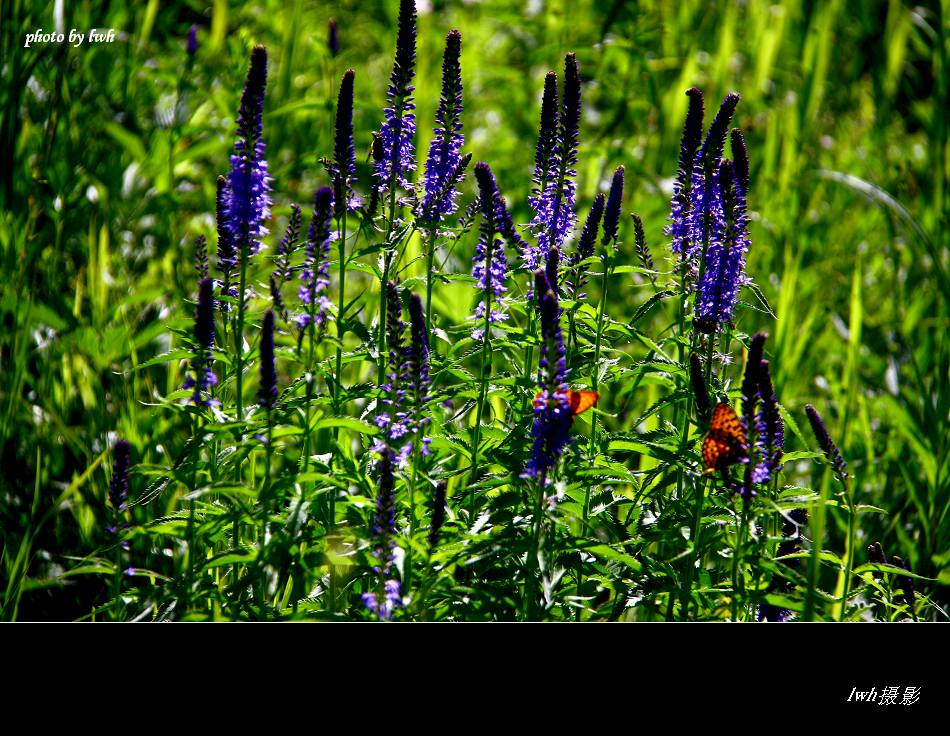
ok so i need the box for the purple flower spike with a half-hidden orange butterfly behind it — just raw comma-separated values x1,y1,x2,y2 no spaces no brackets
522,268,573,485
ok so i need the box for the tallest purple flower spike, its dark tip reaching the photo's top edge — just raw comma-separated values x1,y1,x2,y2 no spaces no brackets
376,0,416,192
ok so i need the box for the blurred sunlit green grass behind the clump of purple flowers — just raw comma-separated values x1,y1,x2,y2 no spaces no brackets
0,0,950,618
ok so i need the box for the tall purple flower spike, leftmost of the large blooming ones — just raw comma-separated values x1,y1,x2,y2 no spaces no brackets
225,46,273,255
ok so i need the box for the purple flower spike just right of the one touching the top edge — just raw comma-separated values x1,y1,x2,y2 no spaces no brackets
419,31,465,225
